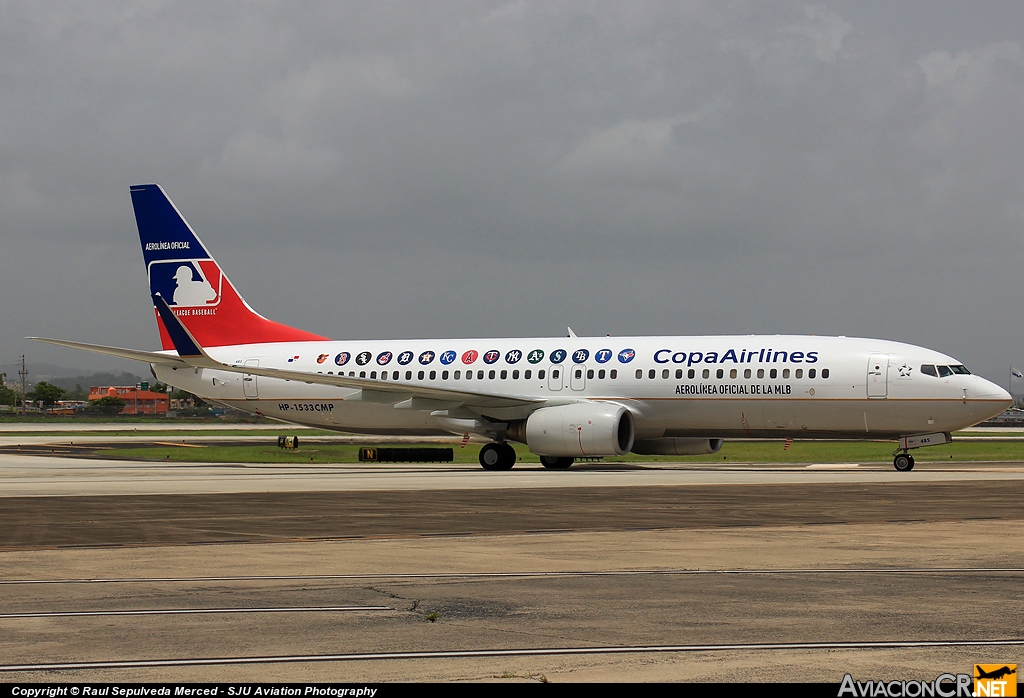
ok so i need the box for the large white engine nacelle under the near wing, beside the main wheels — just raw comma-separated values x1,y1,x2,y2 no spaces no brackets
507,402,636,457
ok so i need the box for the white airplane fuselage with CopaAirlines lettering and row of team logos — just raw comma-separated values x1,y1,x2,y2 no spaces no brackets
154,335,1011,439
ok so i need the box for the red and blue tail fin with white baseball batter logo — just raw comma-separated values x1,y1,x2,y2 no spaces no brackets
131,184,327,349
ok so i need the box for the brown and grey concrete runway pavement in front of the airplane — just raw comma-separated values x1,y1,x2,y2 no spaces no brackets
0,429,1024,682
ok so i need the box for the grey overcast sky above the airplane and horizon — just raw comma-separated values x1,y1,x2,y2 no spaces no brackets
0,0,1024,385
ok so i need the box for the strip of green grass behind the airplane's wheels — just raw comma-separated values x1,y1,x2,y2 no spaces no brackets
97,435,1024,465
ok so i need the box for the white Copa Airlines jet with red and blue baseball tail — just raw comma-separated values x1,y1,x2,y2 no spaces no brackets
30,184,1012,472
